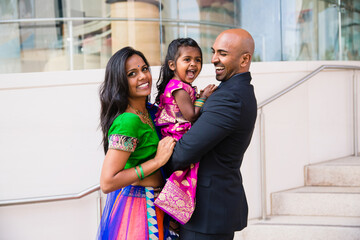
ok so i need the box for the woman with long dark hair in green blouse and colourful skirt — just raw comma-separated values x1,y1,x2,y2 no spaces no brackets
98,47,175,240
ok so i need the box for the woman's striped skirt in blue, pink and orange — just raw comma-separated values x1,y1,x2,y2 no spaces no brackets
97,185,175,240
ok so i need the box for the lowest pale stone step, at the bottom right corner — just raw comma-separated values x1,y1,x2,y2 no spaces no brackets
234,216,360,240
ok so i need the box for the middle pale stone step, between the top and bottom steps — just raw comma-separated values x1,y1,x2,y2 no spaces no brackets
271,186,360,217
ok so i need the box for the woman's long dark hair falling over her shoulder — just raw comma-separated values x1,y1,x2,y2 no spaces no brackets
100,47,150,153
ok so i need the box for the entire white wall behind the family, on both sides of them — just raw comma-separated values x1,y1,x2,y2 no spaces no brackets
0,61,360,240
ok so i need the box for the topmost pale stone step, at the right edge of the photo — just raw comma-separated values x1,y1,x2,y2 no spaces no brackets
305,157,360,187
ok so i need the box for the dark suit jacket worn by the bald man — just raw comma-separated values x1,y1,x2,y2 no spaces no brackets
167,72,257,234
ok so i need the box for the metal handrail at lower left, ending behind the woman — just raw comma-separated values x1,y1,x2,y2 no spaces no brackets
0,184,100,207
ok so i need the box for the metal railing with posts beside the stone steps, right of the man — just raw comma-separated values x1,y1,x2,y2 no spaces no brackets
258,65,360,220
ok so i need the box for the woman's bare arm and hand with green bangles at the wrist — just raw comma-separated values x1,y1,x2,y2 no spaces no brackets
100,137,175,193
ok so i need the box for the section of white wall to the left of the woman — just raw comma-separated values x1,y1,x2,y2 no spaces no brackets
0,70,104,240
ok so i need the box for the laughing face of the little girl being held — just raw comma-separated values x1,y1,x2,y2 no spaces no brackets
169,47,202,83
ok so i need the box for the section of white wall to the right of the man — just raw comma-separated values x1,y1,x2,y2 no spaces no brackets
242,62,360,218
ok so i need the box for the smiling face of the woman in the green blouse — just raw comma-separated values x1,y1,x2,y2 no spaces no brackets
126,54,152,98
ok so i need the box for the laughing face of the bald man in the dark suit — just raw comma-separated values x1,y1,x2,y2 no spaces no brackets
211,34,242,81
